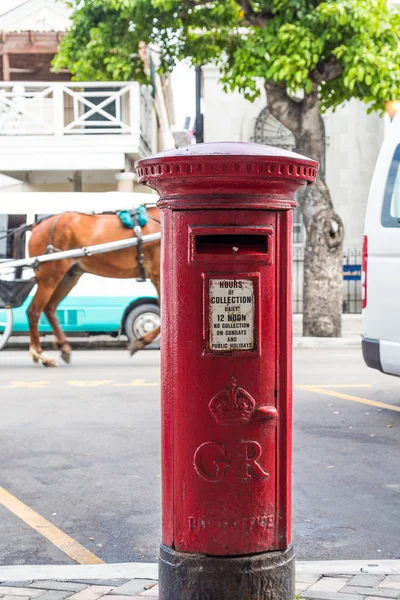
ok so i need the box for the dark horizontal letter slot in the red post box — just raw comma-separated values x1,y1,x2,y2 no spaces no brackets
196,233,268,256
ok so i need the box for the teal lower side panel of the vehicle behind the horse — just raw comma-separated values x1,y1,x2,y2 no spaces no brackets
9,294,157,333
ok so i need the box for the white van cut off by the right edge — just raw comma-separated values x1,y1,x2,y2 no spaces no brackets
362,112,400,375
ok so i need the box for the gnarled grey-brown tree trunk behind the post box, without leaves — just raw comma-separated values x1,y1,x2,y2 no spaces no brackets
266,84,344,337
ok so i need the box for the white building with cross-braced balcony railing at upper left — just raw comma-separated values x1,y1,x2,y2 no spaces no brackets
0,0,174,204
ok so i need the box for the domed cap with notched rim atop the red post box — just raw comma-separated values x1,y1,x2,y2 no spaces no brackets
135,142,319,204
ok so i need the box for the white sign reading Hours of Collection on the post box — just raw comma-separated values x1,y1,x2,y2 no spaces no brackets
208,279,255,352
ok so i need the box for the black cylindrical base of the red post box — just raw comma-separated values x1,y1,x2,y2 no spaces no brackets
159,544,294,600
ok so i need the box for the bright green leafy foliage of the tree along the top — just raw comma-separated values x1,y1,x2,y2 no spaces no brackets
54,0,400,111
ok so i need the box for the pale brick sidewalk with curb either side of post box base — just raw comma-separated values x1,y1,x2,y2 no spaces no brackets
0,560,400,600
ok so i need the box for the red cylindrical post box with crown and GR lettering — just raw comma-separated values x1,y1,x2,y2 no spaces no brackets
137,143,318,600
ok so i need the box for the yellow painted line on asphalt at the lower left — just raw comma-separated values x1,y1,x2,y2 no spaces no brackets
0,487,105,565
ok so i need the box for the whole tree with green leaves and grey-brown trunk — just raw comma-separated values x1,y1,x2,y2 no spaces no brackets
54,0,400,337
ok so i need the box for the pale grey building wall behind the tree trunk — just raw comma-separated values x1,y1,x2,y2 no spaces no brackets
202,65,384,250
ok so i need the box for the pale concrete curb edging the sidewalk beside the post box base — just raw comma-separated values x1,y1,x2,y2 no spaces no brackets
0,560,400,582
